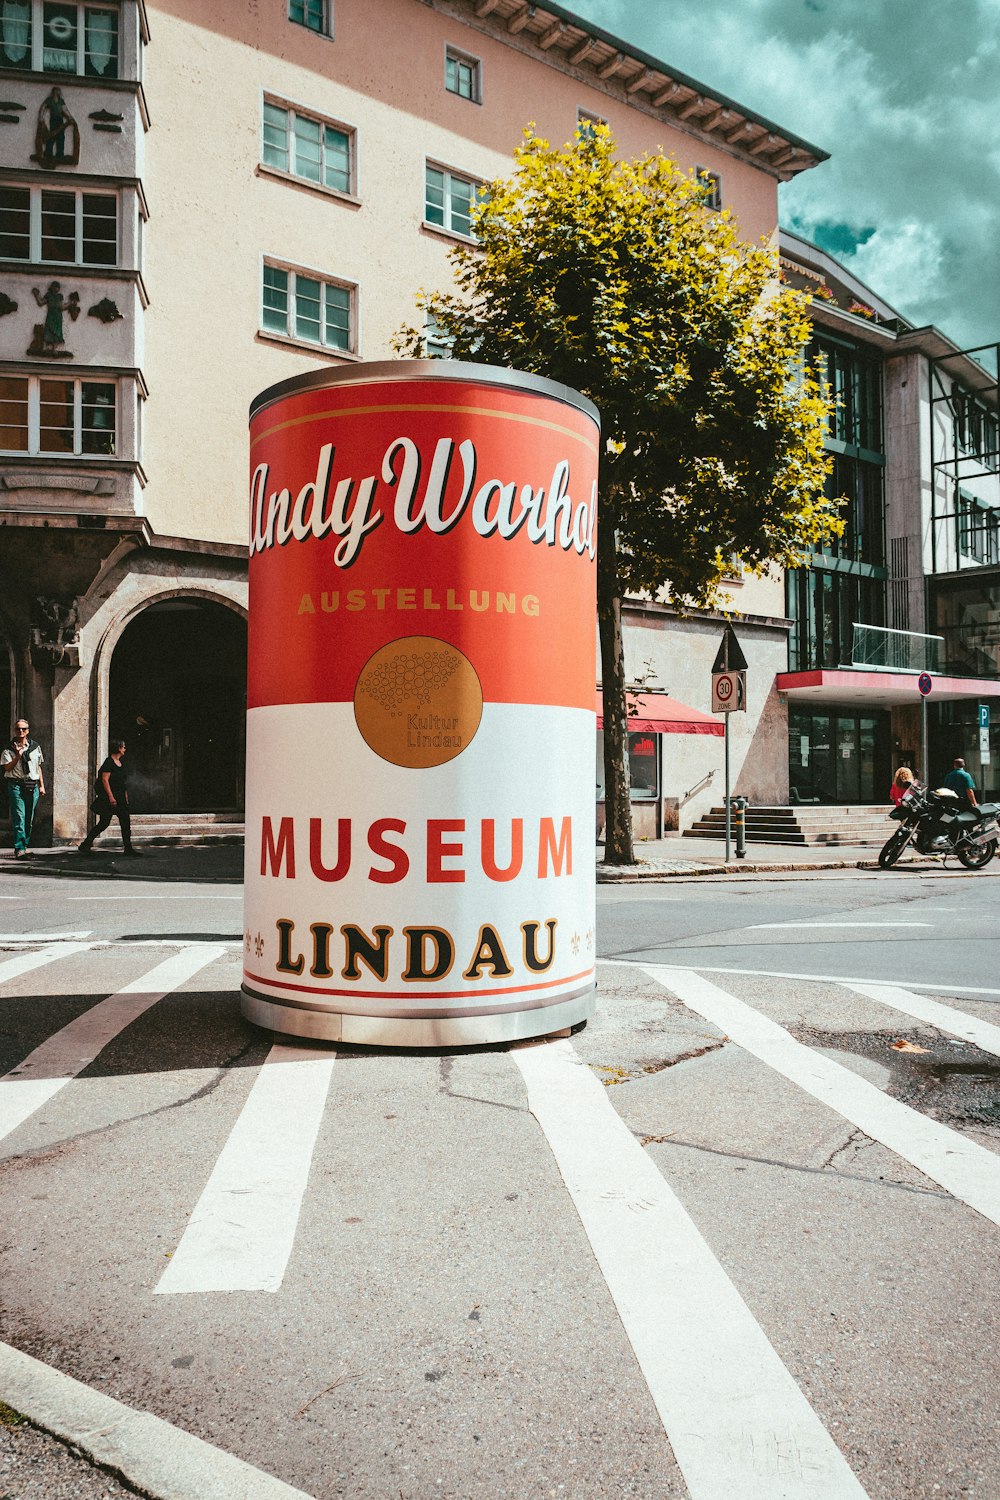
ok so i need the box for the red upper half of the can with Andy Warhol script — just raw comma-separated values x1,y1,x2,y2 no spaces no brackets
249,377,600,711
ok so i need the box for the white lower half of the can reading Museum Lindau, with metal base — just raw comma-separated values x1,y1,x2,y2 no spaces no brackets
241,704,595,1047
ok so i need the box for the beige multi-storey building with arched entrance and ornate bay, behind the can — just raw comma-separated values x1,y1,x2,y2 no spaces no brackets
0,0,822,840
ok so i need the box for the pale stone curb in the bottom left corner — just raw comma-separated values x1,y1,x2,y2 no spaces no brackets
0,1344,313,1500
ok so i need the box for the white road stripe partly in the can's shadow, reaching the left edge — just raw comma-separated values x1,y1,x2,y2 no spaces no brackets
0,944,225,1140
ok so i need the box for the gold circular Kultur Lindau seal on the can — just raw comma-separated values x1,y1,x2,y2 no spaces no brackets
354,636,483,770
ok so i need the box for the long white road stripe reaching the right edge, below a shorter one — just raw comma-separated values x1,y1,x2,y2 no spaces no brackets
636,963,1000,1224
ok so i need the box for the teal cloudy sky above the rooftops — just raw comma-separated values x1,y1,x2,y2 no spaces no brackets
565,0,1000,348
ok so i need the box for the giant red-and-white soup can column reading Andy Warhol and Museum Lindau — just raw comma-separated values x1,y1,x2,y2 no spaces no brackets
241,360,600,1047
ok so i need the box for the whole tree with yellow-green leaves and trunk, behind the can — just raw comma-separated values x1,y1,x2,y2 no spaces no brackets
397,126,841,864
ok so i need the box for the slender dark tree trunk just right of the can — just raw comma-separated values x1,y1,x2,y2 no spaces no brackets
597,507,636,864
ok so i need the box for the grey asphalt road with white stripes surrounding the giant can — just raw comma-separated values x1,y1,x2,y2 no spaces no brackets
0,872,1000,1500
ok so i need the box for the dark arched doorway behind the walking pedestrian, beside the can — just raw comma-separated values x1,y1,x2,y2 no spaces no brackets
108,599,246,813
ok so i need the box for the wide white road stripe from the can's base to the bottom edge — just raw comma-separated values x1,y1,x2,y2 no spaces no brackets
514,1041,865,1500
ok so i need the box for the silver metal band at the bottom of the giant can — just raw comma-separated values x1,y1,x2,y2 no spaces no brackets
240,986,597,1049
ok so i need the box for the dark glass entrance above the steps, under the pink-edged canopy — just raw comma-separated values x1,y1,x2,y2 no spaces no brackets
789,704,892,804
